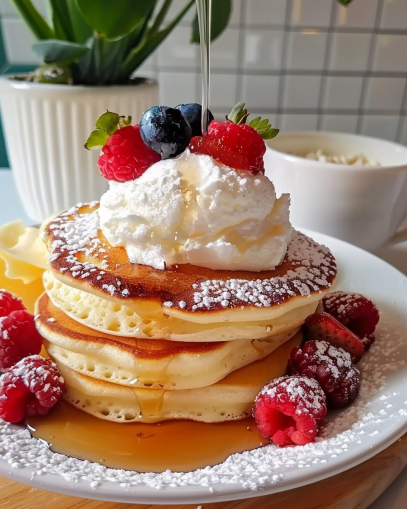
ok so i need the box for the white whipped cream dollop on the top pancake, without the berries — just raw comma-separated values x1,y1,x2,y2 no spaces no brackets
99,150,291,271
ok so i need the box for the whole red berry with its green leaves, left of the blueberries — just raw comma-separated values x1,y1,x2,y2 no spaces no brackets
85,111,161,182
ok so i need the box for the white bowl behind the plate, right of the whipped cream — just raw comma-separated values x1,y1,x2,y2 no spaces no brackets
264,132,407,251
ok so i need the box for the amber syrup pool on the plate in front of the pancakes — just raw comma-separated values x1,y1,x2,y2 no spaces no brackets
27,401,268,473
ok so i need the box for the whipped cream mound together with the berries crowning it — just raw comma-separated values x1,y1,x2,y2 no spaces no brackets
86,103,291,272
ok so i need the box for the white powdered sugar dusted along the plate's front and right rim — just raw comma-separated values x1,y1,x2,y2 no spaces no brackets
0,317,407,491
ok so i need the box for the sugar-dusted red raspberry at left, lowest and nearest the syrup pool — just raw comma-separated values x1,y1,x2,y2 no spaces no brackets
0,355,64,423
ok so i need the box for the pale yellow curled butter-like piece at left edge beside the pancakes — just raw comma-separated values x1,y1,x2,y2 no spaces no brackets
0,220,49,284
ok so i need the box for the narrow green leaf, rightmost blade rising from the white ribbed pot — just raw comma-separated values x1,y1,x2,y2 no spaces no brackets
120,0,195,81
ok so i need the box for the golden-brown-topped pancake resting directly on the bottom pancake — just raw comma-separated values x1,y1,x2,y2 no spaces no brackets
35,294,298,391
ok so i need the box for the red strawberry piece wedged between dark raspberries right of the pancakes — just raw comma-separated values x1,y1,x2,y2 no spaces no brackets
303,313,365,363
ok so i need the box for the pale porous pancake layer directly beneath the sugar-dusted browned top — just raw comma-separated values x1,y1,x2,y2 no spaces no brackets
43,271,317,342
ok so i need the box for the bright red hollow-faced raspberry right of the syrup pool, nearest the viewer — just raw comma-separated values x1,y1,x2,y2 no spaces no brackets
253,376,327,447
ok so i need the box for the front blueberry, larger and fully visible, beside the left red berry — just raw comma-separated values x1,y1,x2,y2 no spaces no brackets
140,106,192,159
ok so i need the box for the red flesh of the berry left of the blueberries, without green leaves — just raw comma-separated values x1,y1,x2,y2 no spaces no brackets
98,125,161,182
